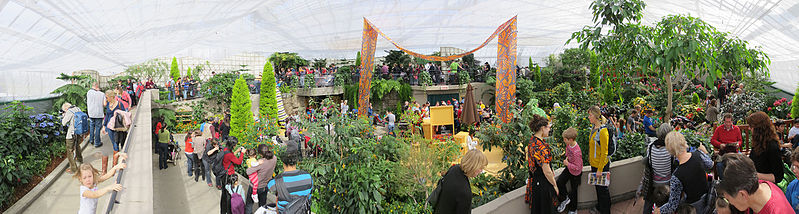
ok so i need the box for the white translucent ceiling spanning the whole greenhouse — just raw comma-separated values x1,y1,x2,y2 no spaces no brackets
0,0,799,96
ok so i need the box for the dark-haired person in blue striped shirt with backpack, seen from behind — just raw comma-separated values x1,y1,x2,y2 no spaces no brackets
266,147,312,214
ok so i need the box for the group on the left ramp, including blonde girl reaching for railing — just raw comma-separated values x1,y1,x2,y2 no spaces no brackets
61,80,154,213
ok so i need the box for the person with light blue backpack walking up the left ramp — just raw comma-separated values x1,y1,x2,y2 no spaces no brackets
61,102,89,174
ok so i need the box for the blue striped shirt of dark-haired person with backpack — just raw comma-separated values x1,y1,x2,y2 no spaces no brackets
266,170,313,210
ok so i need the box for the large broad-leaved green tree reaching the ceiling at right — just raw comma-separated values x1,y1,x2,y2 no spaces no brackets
567,0,770,120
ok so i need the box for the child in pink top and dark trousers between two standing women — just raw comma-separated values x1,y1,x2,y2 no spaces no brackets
556,127,583,214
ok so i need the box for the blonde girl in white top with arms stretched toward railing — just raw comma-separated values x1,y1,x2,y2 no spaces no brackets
73,152,128,214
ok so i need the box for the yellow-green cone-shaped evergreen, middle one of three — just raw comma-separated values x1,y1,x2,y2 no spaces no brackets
230,76,253,138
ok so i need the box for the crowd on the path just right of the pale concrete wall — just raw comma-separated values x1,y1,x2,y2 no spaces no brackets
153,108,313,214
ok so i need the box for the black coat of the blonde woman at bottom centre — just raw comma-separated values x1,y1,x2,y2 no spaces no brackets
434,165,472,214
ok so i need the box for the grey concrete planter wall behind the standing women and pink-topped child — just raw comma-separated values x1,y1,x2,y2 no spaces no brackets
472,156,644,214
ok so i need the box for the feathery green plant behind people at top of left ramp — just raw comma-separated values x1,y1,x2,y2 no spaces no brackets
50,73,94,112
